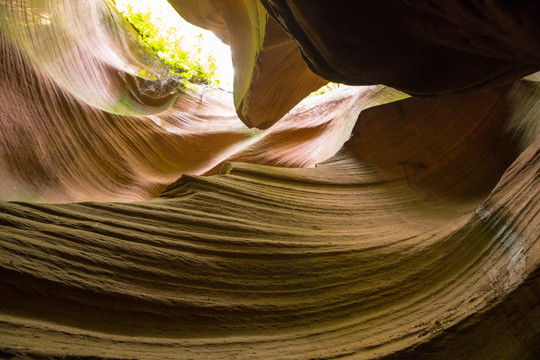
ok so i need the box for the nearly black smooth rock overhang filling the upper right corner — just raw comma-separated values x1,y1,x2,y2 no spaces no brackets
261,0,540,96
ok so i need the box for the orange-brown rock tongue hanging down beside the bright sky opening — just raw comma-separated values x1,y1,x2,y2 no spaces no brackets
170,0,328,129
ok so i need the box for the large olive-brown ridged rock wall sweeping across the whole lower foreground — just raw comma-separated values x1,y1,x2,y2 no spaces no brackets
1,82,540,359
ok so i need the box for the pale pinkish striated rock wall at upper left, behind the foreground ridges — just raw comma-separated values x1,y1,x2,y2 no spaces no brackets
0,1,401,202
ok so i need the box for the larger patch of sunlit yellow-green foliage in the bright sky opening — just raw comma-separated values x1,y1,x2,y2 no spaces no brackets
122,6,219,86
